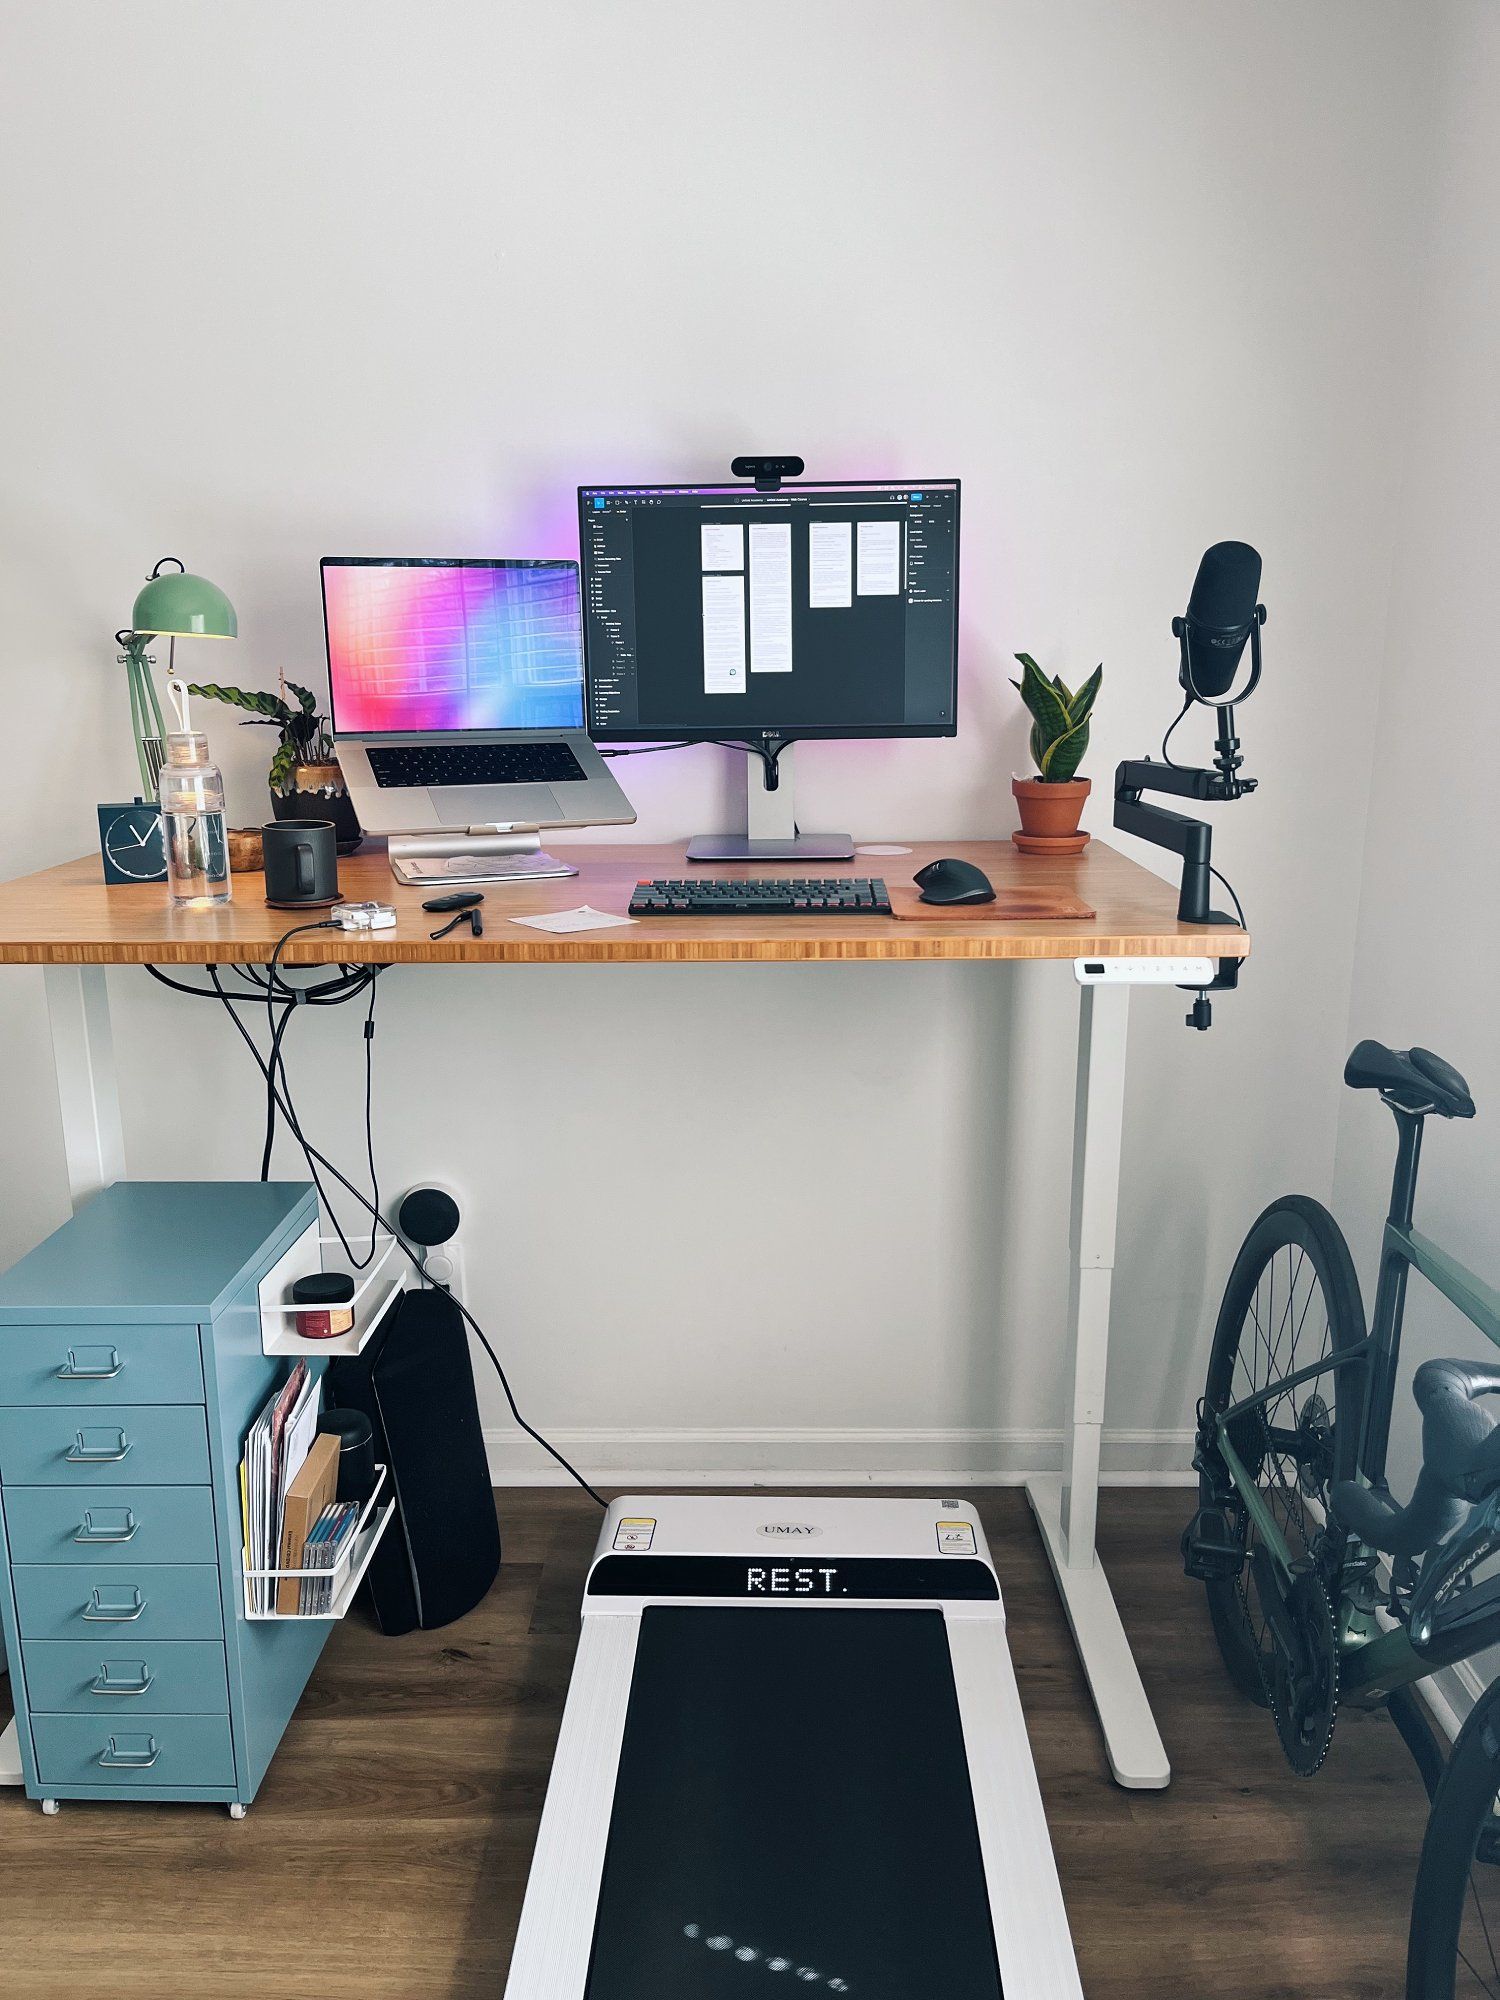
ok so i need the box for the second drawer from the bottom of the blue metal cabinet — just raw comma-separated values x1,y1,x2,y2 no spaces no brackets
22,1626,230,1728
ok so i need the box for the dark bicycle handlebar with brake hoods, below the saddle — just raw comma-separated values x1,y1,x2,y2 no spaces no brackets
1330,1352,1500,1556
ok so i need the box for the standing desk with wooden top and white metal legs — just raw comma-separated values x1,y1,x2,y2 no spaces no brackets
0,840,1250,1788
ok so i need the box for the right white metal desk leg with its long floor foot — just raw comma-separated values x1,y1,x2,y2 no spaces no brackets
1026,986,1172,1790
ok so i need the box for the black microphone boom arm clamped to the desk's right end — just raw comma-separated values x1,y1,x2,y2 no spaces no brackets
1114,604,1266,1028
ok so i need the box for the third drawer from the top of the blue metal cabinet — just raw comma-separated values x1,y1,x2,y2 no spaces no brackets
4,1488,218,1564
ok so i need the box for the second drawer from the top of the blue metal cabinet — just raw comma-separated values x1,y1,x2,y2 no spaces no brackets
0,1404,208,1486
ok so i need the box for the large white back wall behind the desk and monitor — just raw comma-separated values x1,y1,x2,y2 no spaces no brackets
0,0,1430,1472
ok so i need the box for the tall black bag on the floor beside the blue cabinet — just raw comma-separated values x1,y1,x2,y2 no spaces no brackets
324,1286,500,1634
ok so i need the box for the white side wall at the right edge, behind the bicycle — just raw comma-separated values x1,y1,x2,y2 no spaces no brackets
1334,0,1500,1494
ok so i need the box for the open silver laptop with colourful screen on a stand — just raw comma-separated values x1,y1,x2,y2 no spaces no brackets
322,556,636,834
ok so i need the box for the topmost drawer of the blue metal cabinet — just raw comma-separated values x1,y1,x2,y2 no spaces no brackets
0,1324,204,1406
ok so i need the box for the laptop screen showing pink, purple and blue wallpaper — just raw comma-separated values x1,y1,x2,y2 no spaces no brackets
322,556,584,736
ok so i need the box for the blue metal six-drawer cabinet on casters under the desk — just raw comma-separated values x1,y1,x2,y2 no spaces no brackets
0,1180,330,1814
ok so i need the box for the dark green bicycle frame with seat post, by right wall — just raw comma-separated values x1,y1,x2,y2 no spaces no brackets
1216,1106,1500,1704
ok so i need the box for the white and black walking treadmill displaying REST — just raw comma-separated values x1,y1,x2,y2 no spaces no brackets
506,1494,1082,2000
